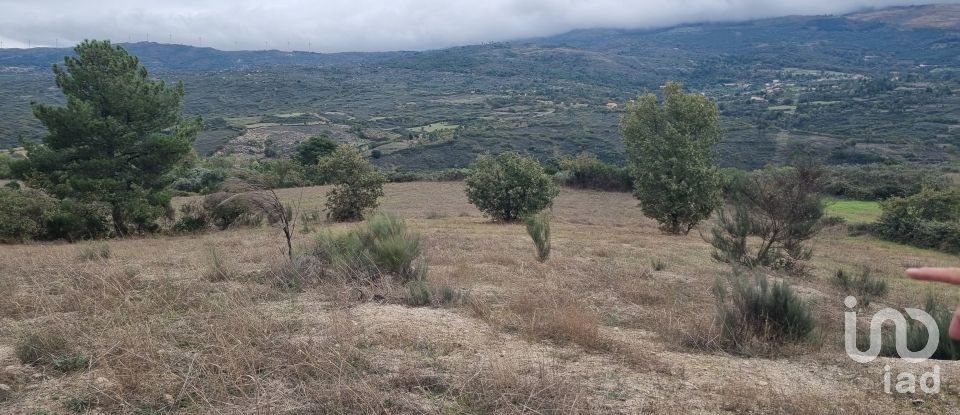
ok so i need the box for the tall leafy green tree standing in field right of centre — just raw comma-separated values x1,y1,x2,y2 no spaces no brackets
620,82,722,234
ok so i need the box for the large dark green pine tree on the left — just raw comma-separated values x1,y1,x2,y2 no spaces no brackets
18,40,201,235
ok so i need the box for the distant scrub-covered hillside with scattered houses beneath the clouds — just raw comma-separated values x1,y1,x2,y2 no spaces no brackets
0,5,960,169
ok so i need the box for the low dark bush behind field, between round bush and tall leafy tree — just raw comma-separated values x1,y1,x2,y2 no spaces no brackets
554,153,633,192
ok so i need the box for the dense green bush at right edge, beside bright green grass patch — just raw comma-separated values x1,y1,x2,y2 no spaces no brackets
871,189,960,254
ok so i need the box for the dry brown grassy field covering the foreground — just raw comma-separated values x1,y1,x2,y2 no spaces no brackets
0,183,960,414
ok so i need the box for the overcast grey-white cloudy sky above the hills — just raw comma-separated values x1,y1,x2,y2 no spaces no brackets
0,0,960,52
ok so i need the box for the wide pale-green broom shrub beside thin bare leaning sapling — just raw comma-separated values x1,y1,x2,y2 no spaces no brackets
313,214,427,282
